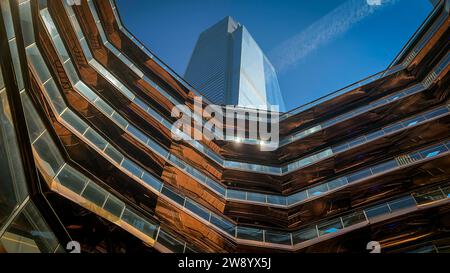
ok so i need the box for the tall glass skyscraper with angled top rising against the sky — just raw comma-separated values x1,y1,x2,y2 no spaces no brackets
185,16,285,112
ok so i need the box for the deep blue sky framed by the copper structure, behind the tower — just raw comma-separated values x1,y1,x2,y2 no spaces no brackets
117,0,432,109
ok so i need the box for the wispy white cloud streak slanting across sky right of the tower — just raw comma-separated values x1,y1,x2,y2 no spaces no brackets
270,0,397,73
